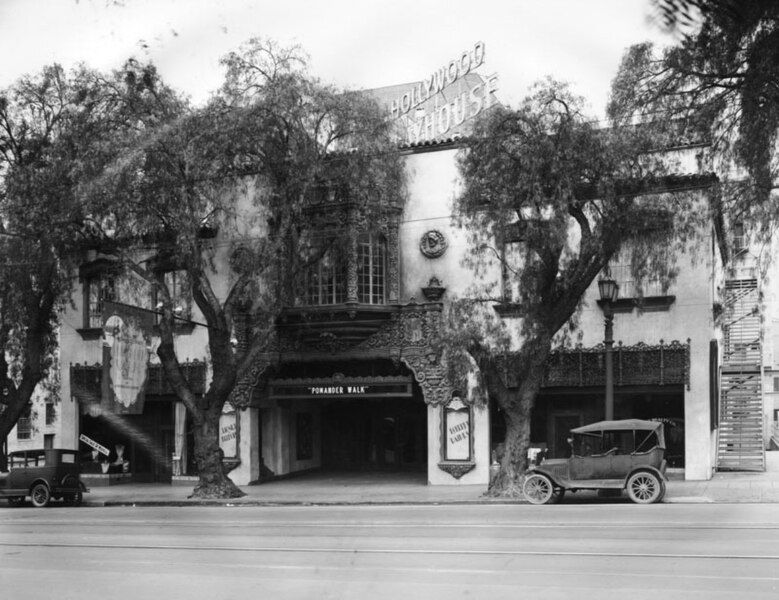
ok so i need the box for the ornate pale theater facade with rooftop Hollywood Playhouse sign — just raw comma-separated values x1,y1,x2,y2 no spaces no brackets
10,43,768,485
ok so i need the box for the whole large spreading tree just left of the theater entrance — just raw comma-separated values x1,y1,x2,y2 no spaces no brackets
86,39,412,497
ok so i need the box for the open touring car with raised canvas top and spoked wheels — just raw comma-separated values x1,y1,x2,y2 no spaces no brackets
522,419,666,504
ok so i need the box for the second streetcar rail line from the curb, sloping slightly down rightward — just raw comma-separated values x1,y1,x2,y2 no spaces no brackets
0,542,779,561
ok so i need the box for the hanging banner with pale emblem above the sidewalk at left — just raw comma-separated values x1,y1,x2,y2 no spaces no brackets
101,302,154,415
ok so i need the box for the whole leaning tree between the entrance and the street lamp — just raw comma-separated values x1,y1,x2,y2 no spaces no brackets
450,82,691,494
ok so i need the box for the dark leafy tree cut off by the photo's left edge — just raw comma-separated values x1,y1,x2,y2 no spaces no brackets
0,65,101,462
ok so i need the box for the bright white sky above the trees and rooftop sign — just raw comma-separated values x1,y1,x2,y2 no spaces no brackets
0,0,674,118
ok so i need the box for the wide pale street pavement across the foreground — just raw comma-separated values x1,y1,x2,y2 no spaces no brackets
0,504,779,600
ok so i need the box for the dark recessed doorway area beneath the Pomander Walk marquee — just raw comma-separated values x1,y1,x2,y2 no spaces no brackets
322,398,427,471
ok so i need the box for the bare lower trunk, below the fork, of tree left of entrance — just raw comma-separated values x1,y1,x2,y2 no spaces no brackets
190,411,246,498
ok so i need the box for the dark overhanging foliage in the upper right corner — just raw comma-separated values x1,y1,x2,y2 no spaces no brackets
620,0,779,253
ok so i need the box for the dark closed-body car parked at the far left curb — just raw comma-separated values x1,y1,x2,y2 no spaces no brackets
0,448,89,507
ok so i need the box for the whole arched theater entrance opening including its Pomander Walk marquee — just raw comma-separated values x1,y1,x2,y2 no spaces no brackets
259,359,428,476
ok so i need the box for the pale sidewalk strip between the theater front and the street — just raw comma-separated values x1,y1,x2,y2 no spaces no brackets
84,460,779,506
